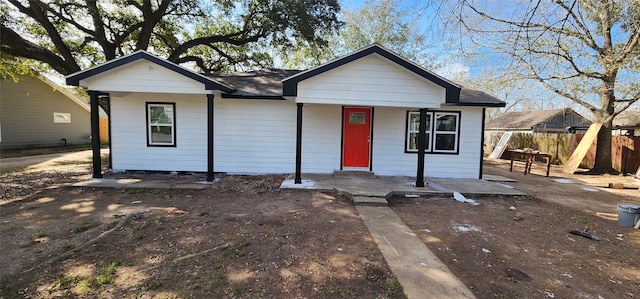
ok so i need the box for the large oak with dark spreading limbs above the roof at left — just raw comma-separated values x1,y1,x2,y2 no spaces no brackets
0,0,340,75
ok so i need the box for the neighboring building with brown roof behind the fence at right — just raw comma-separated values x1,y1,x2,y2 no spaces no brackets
485,108,591,133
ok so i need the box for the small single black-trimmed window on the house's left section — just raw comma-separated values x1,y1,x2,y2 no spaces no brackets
147,103,176,146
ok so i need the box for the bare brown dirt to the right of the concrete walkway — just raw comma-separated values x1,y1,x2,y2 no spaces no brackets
392,163,640,298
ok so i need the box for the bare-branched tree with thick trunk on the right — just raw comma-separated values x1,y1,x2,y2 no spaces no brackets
455,0,640,173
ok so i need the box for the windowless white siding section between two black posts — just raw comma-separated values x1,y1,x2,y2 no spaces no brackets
214,99,296,174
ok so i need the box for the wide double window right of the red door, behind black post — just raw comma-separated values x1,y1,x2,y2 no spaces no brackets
405,111,460,154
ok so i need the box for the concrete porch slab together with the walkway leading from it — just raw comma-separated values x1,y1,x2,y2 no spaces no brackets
281,174,525,299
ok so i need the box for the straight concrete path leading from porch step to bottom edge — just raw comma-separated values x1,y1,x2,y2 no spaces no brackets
356,206,475,299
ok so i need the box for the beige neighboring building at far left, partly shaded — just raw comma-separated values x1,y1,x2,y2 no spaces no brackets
0,76,105,149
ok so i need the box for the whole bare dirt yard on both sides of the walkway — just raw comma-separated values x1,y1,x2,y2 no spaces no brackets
0,152,640,298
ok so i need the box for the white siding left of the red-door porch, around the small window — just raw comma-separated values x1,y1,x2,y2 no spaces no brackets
111,93,296,174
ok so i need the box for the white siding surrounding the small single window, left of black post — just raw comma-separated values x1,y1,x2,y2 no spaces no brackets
111,93,207,171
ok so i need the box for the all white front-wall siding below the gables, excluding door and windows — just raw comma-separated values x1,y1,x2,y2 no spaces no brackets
111,93,482,178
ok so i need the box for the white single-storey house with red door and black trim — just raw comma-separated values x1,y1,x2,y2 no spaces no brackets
67,45,504,186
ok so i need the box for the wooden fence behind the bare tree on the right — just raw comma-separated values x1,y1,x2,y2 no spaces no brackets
484,132,640,173
